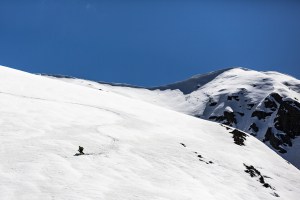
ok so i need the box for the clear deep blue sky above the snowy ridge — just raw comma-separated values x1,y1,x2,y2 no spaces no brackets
0,0,300,86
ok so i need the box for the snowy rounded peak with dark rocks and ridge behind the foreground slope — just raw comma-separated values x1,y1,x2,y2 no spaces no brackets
48,68,300,168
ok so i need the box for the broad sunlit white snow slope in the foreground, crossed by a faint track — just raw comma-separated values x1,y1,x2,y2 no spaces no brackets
0,67,300,200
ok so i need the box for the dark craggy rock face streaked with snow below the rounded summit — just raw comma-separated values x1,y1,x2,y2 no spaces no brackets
208,90,300,158
